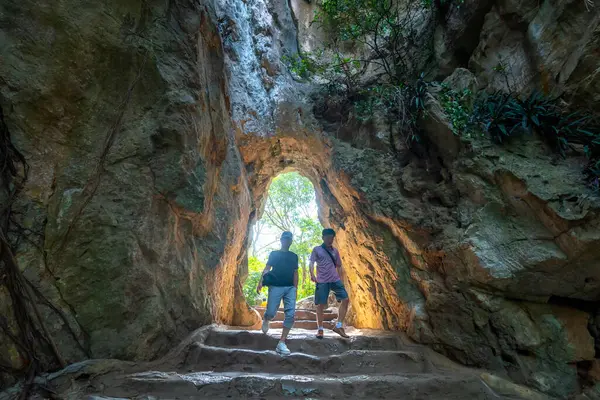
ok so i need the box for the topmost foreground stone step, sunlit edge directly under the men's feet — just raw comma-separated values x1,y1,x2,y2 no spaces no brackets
204,329,409,356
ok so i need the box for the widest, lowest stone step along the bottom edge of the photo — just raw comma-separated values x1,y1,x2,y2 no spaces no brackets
101,371,505,400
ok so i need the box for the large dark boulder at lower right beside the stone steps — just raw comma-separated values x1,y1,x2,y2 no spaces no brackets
420,289,594,397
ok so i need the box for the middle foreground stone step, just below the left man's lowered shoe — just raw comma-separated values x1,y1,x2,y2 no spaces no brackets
179,343,431,374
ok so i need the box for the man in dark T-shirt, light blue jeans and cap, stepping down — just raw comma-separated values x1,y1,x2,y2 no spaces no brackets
256,232,298,356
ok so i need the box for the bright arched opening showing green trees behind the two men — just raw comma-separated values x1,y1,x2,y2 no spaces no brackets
243,171,323,307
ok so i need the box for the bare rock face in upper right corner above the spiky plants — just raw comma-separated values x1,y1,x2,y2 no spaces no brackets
469,0,600,100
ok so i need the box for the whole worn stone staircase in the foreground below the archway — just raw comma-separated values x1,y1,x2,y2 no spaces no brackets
9,324,548,400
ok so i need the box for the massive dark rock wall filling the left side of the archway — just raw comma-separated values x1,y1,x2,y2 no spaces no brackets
0,1,250,362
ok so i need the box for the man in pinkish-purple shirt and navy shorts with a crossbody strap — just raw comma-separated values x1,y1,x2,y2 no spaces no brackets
309,229,350,339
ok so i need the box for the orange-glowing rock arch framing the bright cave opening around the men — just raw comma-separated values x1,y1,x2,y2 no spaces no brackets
221,135,423,330
